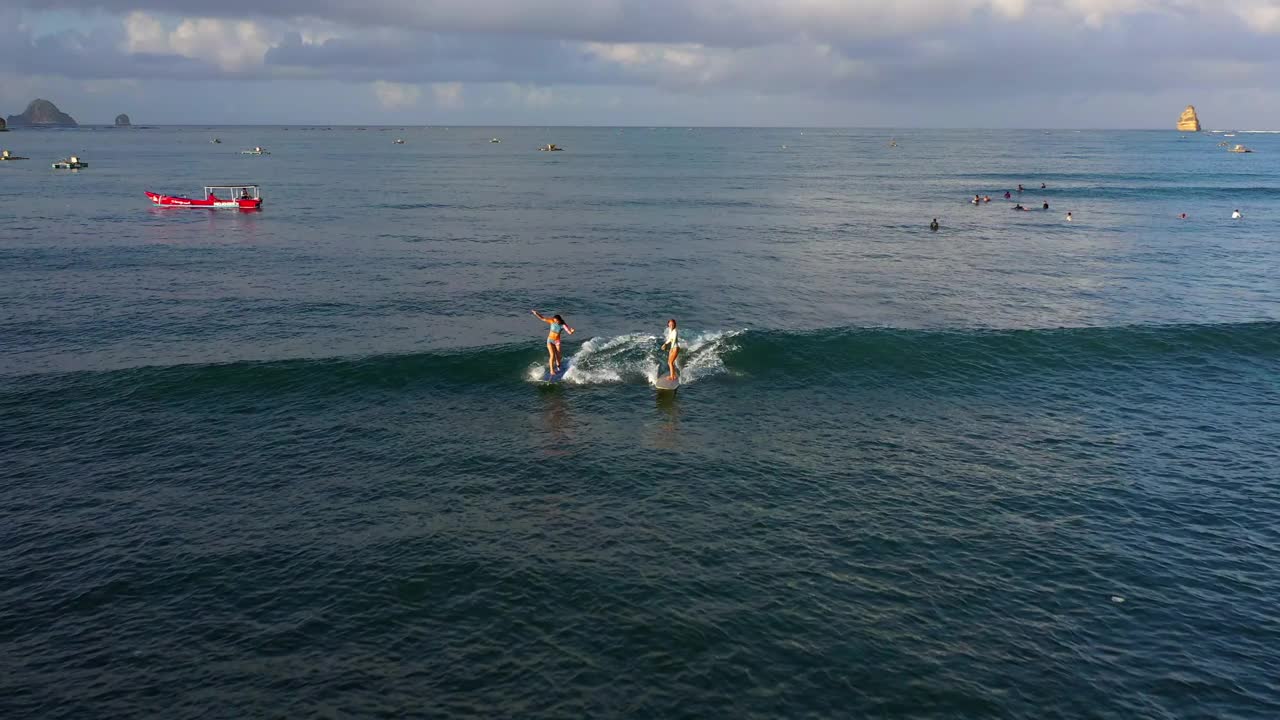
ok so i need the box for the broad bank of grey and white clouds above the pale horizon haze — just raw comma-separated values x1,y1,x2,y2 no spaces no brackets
0,0,1280,122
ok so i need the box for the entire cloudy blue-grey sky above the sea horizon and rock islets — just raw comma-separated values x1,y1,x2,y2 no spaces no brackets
0,0,1280,129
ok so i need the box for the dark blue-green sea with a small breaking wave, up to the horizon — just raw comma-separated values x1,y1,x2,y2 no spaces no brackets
0,128,1280,717
